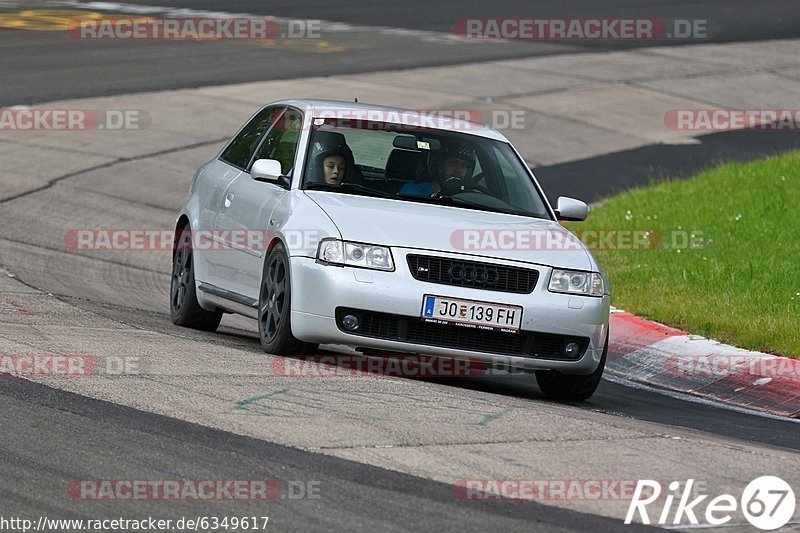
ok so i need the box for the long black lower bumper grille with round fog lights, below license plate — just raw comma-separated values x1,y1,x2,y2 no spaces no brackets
336,307,589,360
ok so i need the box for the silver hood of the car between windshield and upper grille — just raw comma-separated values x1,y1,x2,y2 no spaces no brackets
306,191,593,270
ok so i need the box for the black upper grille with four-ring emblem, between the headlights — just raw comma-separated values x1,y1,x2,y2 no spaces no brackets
406,255,539,294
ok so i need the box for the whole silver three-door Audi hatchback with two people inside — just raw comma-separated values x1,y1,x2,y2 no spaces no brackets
170,100,610,400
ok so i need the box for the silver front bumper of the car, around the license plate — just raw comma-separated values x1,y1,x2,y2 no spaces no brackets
290,248,610,374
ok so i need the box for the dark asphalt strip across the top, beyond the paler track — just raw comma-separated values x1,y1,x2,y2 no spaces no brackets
0,0,800,106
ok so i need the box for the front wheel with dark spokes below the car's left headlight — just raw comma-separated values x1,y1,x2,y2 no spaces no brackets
258,243,317,355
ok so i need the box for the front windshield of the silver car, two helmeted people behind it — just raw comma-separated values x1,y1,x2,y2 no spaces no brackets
303,119,551,219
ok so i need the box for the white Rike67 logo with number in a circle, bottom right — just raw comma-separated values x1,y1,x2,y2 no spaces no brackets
625,476,795,531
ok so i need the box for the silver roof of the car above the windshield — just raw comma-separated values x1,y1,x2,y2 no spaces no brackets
268,99,508,142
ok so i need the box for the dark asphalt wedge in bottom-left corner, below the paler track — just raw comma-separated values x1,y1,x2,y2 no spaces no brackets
0,379,649,532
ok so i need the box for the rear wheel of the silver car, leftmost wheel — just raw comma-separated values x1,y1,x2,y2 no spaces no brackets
169,226,222,331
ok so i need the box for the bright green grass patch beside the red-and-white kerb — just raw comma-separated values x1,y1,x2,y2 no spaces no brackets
569,151,800,358
